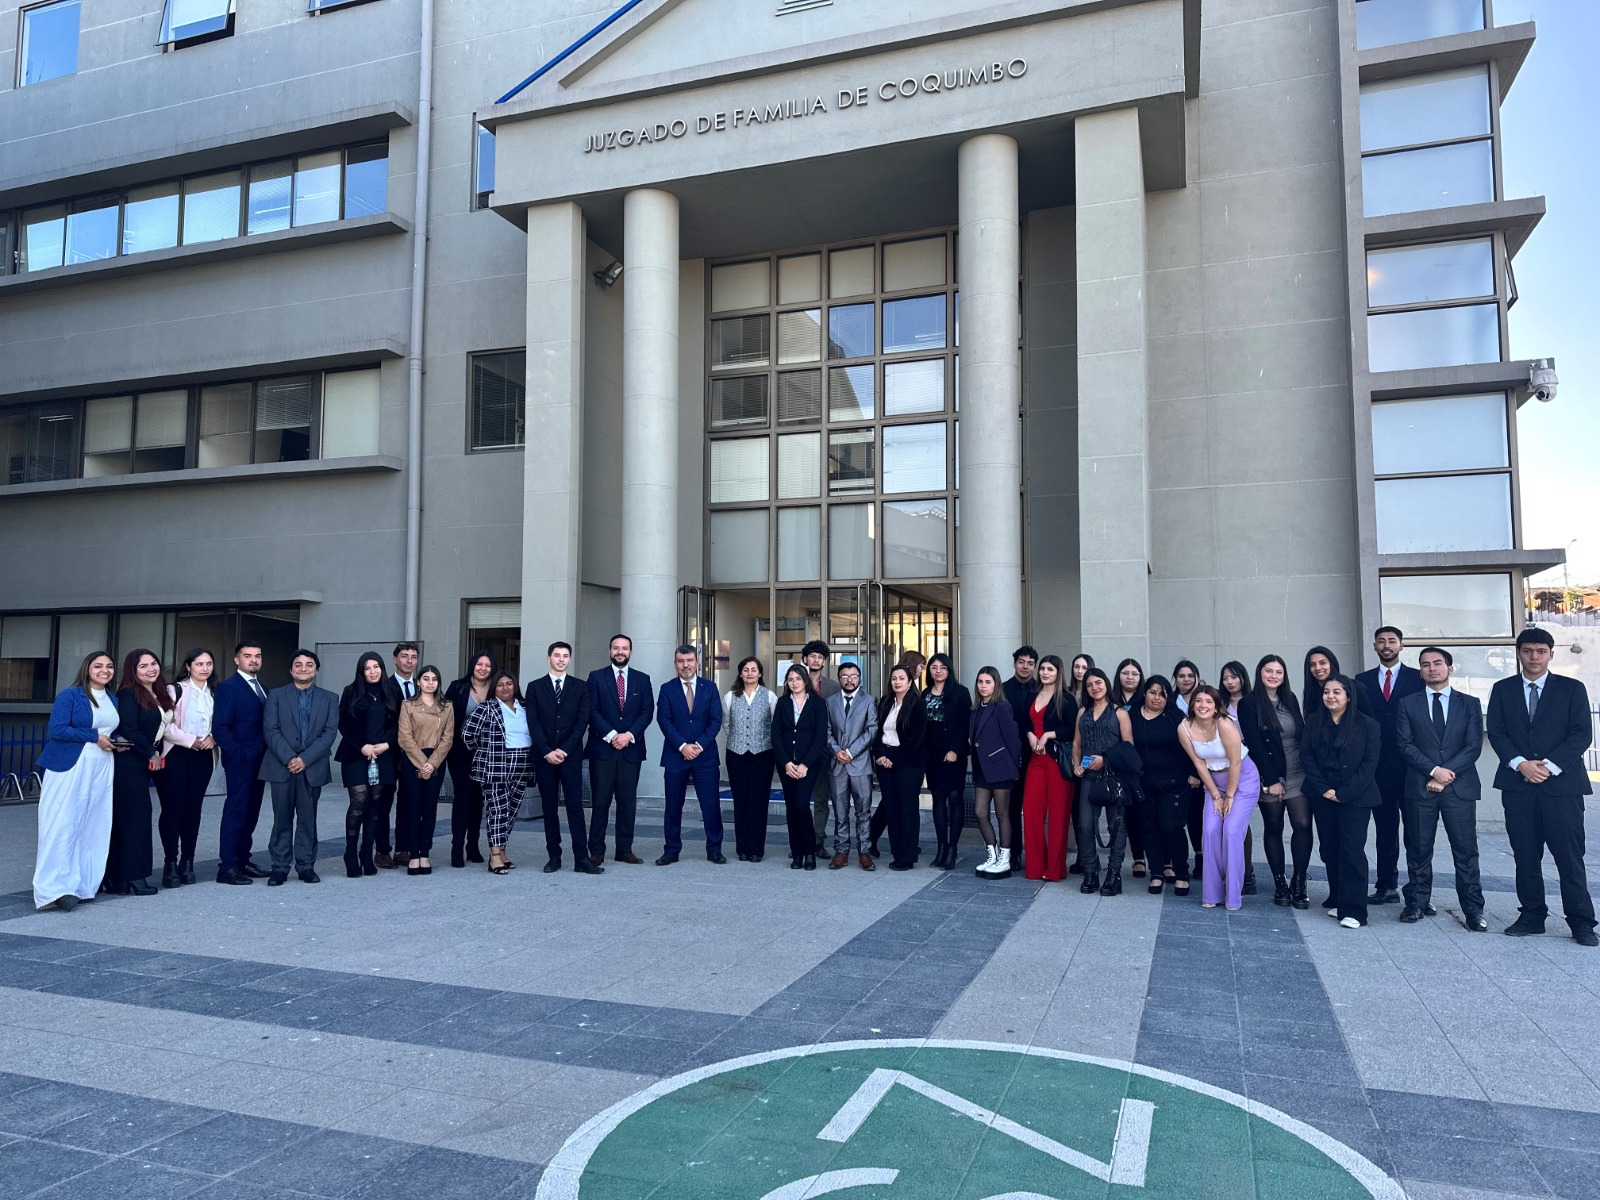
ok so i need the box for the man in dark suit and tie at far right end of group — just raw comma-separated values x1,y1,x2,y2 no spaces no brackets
1488,629,1600,946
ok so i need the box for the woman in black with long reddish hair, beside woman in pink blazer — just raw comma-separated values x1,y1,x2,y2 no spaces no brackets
106,650,173,896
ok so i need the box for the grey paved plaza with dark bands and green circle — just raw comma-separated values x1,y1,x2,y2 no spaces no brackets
0,802,1600,1200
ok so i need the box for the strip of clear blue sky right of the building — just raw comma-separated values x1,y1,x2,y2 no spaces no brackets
1494,0,1600,584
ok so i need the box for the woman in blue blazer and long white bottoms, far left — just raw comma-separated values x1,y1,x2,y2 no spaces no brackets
34,650,117,912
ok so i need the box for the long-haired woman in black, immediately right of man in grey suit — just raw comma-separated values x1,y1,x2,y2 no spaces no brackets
333,650,400,878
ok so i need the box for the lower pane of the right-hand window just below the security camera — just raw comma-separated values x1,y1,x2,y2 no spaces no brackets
1378,475,1512,554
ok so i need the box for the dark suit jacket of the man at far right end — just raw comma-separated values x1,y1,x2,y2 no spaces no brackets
1488,672,1594,795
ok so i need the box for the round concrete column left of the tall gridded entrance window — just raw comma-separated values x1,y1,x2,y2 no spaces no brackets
622,189,678,685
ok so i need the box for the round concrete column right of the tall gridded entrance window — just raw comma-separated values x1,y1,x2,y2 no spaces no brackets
955,133,1022,678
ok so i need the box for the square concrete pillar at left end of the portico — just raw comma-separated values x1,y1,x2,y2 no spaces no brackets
522,203,589,643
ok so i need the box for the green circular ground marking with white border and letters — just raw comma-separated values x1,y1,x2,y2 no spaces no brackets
534,1040,1405,1200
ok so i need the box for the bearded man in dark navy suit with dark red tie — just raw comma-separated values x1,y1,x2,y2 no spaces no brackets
587,634,656,866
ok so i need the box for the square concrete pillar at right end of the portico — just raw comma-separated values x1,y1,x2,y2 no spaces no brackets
1062,109,1150,669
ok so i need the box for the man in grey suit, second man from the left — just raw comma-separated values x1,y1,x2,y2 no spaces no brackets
261,650,339,888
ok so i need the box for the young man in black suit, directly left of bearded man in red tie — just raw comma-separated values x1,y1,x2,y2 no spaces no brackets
522,642,605,875
